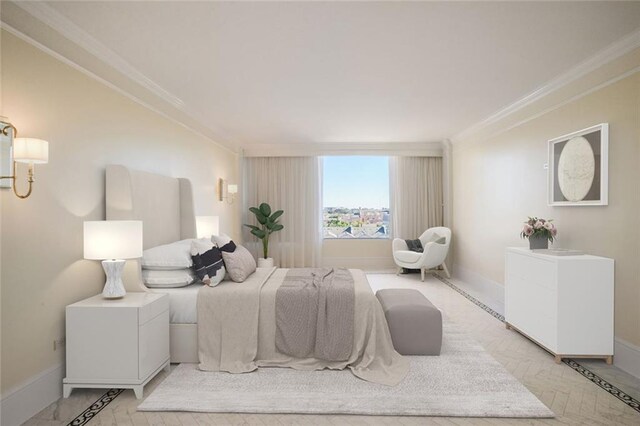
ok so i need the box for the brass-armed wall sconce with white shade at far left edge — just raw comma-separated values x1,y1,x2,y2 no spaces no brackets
0,123,49,199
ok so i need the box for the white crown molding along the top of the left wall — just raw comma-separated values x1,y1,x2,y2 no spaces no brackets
8,1,238,153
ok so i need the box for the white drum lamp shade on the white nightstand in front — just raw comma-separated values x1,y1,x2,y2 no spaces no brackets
84,220,142,260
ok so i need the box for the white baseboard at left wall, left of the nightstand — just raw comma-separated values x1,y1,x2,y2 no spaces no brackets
0,364,64,426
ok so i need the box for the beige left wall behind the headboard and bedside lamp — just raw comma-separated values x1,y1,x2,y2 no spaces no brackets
0,31,239,393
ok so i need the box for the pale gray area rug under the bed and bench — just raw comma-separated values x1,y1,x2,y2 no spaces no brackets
138,323,554,418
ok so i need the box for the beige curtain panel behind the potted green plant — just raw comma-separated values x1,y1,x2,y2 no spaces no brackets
242,157,322,268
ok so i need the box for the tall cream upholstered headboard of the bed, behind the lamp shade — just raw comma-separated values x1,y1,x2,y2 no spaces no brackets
106,165,196,249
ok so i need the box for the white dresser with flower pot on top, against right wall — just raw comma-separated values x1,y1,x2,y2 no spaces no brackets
505,247,614,364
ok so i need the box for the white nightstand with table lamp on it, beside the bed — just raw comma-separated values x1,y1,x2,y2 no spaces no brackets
62,292,169,399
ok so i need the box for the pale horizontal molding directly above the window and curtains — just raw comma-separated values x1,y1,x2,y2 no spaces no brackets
243,142,443,157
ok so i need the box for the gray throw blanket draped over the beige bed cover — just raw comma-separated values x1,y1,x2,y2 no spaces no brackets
276,268,355,361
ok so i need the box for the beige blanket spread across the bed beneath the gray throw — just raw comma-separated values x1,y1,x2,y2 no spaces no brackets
198,269,409,386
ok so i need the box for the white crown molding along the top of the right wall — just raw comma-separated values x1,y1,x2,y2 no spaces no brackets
451,30,640,144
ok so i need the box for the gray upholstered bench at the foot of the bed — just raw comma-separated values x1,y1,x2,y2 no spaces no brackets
376,288,442,355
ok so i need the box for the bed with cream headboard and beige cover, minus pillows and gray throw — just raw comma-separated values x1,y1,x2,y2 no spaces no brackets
106,165,409,385
